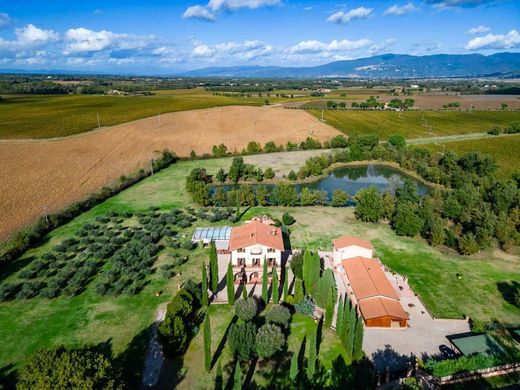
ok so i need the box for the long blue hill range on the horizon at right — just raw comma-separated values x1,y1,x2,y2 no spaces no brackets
182,53,520,78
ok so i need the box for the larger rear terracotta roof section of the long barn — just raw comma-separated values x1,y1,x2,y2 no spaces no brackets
341,257,399,301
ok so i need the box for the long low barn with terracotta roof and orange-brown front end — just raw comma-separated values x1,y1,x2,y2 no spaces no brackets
341,256,408,328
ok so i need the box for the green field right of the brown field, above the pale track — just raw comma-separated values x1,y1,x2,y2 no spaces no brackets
309,110,520,140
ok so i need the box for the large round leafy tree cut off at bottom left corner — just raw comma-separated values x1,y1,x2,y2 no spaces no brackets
16,346,121,390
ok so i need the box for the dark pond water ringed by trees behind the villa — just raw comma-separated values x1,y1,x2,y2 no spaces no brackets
213,164,429,201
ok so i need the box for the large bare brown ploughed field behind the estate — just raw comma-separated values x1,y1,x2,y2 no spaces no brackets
0,107,338,238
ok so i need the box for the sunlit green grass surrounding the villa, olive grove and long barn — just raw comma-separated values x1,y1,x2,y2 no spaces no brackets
0,156,520,388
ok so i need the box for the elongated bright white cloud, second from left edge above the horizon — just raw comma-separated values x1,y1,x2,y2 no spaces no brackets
64,27,155,55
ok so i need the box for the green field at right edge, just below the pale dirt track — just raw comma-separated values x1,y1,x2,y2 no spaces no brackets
419,134,520,177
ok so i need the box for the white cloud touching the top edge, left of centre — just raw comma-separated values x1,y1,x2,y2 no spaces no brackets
182,0,282,21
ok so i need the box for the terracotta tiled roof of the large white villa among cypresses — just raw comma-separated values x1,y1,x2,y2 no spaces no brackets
229,221,284,251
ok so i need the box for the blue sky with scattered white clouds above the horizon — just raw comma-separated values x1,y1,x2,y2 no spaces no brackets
0,0,520,74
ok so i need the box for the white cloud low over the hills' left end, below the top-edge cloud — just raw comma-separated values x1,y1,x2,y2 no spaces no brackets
191,41,274,61
